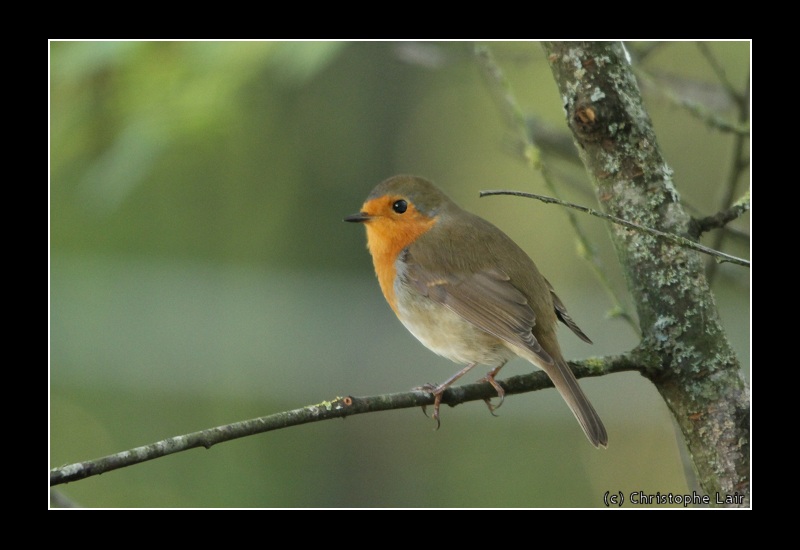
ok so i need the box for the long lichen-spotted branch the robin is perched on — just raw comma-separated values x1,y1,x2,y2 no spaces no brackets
50,353,641,486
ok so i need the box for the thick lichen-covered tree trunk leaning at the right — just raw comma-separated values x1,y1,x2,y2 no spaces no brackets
544,42,750,506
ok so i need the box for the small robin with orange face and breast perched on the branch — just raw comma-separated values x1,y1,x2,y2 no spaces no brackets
345,175,608,447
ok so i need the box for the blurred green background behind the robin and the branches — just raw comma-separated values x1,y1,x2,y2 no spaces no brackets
49,42,750,507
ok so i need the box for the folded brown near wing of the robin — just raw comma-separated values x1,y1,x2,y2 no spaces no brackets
406,262,554,365
